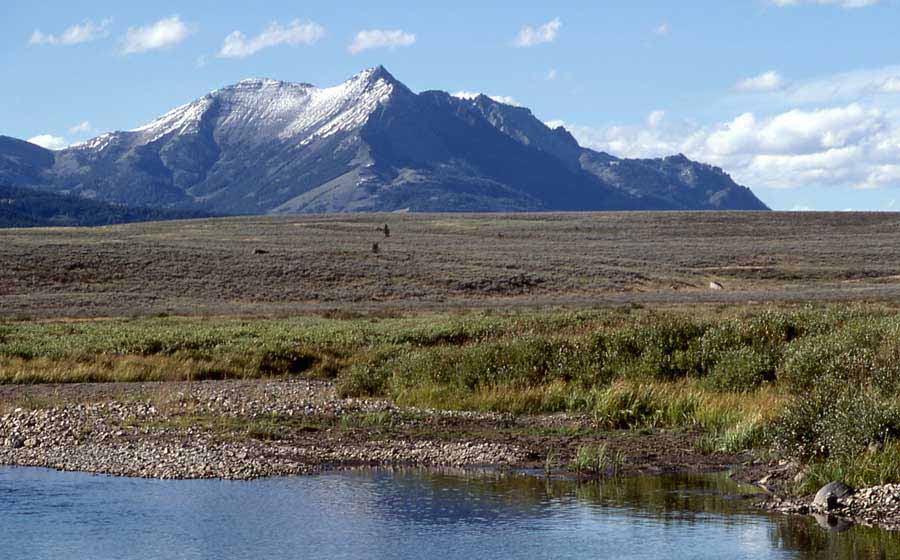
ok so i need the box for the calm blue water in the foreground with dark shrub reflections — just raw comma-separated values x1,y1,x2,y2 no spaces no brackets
0,468,900,560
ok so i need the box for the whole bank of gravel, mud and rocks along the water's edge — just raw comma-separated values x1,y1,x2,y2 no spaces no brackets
0,380,900,530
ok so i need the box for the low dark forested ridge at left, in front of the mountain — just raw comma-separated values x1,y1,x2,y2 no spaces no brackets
0,185,208,228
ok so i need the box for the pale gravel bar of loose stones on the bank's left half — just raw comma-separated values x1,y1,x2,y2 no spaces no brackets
0,381,527,480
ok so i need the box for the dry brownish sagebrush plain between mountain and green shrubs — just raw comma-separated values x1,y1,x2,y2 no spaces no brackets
0,212,900,320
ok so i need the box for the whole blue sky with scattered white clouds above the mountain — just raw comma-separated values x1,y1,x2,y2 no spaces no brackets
0,0,900,210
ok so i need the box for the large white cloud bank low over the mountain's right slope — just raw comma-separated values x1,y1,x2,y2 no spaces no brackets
548,103,900,192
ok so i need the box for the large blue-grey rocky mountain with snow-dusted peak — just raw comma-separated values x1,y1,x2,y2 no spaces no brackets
0,66,766,214
